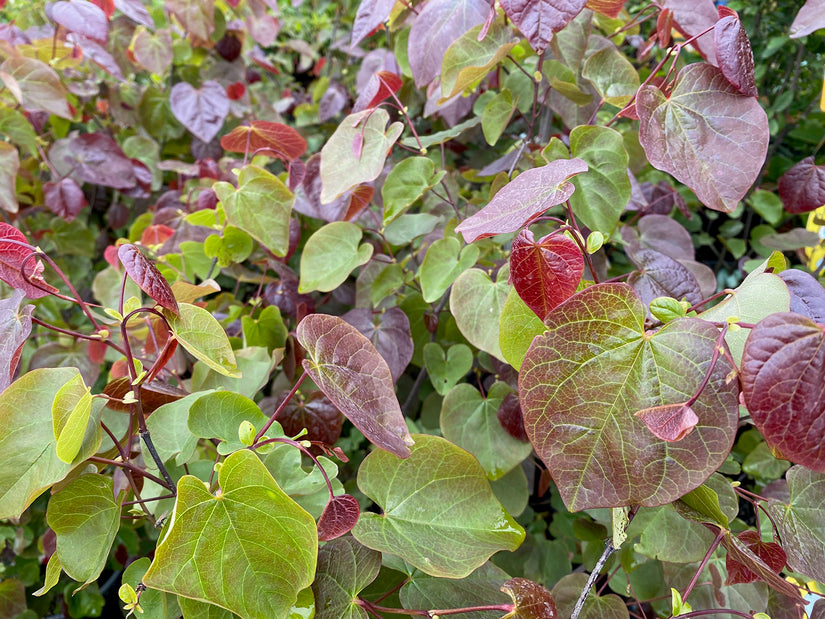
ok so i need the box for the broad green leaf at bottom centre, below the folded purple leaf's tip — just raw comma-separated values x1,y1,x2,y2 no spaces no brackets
352,435,524,578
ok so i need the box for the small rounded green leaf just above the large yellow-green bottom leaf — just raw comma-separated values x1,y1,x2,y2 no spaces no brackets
187,391,272,454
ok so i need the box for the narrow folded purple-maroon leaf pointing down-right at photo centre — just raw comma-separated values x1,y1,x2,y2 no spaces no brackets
296,314,412,458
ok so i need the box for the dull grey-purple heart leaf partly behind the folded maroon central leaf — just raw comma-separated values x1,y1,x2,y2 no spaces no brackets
341,307,415,382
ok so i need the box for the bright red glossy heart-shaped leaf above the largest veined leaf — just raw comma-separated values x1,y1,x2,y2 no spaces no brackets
510,228,584,320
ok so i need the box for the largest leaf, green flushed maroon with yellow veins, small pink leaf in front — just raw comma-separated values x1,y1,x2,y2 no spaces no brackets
519,284,739,511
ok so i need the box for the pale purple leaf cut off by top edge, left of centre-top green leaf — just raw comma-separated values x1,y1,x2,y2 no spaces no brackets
407,0,490,88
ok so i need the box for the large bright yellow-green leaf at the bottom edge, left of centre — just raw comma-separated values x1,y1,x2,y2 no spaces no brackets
143,449,318,617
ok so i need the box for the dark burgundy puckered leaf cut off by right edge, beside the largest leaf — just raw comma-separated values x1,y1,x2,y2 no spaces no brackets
741,312,825,473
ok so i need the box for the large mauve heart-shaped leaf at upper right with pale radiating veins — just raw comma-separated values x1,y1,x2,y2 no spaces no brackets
636,63,769,213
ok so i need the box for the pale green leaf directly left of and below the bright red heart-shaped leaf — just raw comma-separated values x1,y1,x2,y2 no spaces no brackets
450,265,510,360
